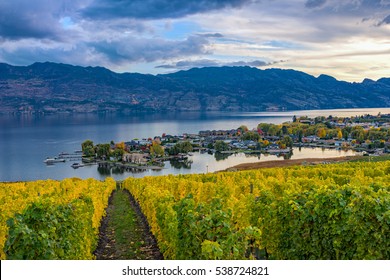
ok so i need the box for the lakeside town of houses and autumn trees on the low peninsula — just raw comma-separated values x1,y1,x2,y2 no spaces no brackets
68,114,390,171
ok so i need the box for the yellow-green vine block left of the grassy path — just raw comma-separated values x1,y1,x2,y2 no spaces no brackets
0,179,116,259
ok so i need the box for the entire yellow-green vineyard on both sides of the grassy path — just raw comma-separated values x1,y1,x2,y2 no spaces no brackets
0,161,390,260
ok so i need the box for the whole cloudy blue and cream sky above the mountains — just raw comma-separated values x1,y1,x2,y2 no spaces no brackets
0,0,390,82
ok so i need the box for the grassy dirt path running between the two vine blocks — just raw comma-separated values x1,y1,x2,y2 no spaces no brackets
94,190,163,260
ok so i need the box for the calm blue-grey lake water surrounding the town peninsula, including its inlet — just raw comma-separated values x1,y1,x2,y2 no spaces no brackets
0,108,390,181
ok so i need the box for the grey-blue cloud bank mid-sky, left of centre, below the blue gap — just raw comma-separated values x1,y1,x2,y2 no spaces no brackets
89,36,209,63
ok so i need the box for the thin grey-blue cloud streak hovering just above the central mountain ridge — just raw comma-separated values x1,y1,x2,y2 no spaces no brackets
156,59,274,69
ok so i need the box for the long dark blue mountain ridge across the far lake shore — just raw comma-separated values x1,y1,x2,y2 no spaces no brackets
0,62,390,113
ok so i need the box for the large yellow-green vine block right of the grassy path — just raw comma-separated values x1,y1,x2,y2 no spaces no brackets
123,161,390,259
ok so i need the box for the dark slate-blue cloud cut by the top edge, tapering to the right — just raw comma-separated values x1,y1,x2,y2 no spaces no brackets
82,0,253,20
